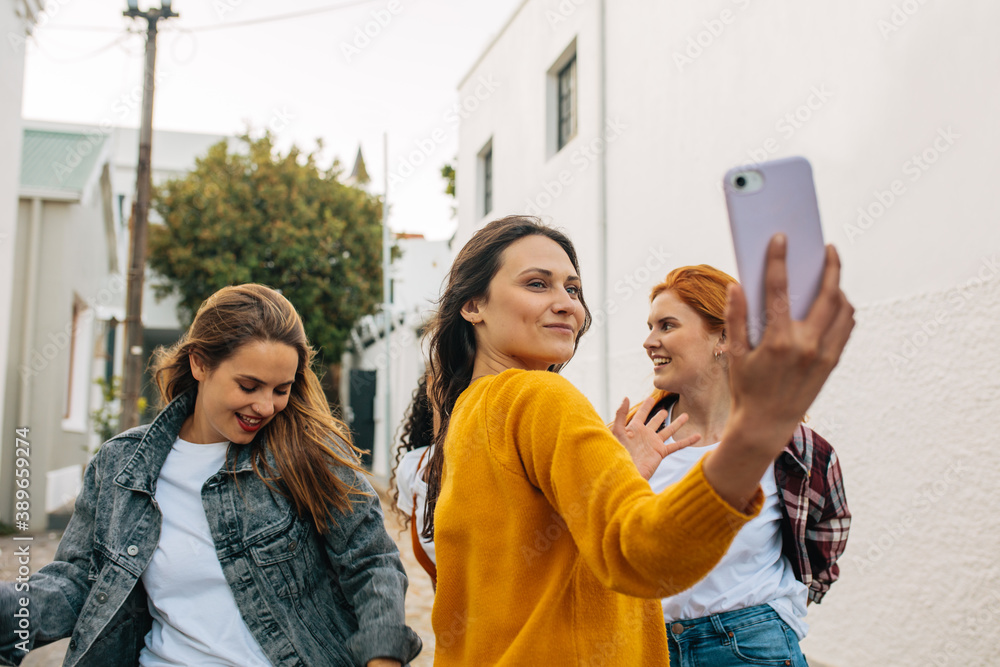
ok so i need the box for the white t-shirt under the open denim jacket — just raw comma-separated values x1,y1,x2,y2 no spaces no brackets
139,438,271,667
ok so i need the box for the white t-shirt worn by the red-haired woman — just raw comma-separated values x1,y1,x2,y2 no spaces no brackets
649,418,809,640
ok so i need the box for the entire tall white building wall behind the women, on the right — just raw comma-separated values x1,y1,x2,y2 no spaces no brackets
455,0,1000,667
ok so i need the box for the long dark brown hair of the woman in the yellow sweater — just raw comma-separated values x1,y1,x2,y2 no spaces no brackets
422,215,591,538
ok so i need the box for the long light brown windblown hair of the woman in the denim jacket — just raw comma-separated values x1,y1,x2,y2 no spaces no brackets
153,284,367,534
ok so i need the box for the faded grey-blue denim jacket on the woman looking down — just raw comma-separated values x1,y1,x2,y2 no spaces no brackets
0,392,421,667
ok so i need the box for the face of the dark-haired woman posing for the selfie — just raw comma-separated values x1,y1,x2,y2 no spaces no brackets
462,235,586,376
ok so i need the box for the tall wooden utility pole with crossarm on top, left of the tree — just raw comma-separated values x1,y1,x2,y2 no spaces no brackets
118,0,178,431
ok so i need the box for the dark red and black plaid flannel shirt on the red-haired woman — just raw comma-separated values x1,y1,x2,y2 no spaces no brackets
774,424,851,603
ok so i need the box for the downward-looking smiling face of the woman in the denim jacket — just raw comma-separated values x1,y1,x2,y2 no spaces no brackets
180,340,299,445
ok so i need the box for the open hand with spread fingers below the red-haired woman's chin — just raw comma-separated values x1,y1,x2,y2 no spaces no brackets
611,396,701,480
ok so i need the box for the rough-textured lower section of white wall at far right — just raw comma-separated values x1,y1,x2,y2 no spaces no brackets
804,268,1000,667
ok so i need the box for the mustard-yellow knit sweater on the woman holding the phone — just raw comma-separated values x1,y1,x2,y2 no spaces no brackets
432,370,760,667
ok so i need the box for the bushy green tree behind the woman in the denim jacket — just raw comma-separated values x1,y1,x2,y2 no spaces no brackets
149,134,382,363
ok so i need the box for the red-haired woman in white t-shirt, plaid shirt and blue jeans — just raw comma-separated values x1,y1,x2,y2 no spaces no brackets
644,264,851,667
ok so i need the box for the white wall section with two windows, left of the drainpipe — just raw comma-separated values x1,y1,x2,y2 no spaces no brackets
453,2,604,400
